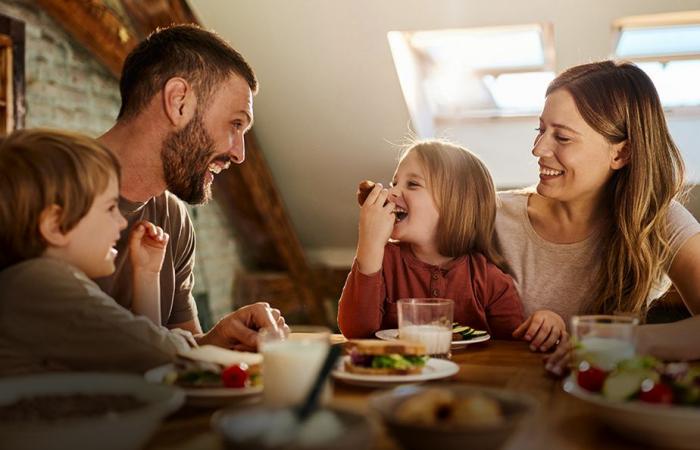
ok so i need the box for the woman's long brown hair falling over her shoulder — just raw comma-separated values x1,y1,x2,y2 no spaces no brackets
547,61,685,313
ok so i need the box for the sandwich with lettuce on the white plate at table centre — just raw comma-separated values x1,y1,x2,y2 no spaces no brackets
345,339,428,375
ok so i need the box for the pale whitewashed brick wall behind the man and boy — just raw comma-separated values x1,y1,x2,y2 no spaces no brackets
0,0,239,326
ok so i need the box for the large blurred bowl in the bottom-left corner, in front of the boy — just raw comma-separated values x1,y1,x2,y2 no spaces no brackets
0,373,185,450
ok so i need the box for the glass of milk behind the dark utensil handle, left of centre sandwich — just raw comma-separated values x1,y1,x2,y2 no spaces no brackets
258,326,330,407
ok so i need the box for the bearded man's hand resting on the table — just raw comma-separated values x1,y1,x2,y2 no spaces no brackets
197,302,289,351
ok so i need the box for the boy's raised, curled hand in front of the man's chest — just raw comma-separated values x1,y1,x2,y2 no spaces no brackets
129,220,169,273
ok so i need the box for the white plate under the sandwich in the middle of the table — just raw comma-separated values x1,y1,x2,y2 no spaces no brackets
333,356,459,387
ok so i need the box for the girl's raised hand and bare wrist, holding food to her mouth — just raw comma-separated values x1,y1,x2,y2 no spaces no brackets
357,183,396,275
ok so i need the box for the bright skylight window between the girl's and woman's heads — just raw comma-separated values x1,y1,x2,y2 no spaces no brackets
388,24,554,134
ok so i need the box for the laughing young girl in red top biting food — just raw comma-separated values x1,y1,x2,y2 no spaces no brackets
338,141,523,339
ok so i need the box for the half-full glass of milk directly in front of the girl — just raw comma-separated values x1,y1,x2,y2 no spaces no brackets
398,298,454,358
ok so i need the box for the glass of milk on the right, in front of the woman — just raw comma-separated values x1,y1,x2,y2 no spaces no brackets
571,315,639,371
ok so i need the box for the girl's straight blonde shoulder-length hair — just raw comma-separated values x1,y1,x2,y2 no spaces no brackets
402,140,503,267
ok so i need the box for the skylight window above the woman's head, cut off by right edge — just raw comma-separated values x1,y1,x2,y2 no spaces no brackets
614,11,700,109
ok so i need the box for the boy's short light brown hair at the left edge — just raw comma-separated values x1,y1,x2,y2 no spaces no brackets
0,129,120,269
